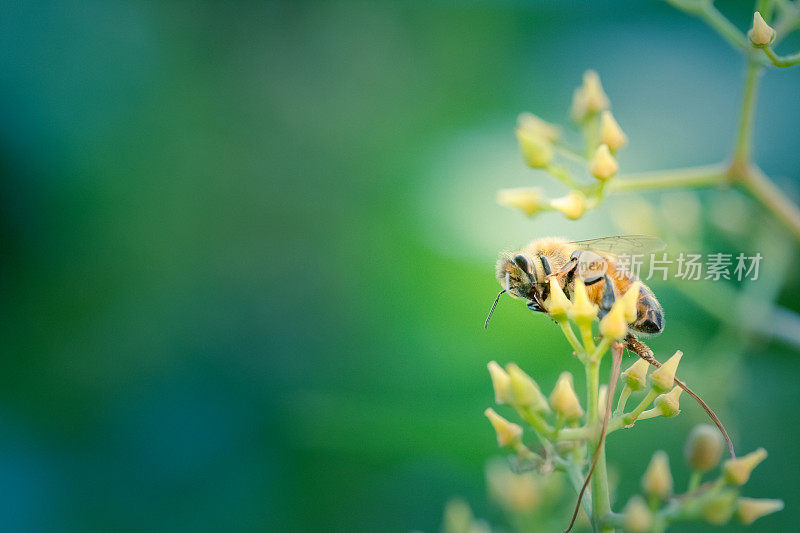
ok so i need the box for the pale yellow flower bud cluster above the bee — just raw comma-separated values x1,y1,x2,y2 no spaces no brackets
497,70,628,220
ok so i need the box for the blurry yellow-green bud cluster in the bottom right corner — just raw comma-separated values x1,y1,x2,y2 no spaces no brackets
622,425,783,533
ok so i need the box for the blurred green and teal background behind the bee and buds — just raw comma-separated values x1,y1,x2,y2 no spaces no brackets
0,1,800,531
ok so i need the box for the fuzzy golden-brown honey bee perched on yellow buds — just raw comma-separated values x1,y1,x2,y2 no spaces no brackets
487,235,665,336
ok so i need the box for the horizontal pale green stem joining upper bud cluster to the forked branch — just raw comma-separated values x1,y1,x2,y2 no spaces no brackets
608,165,729,192
